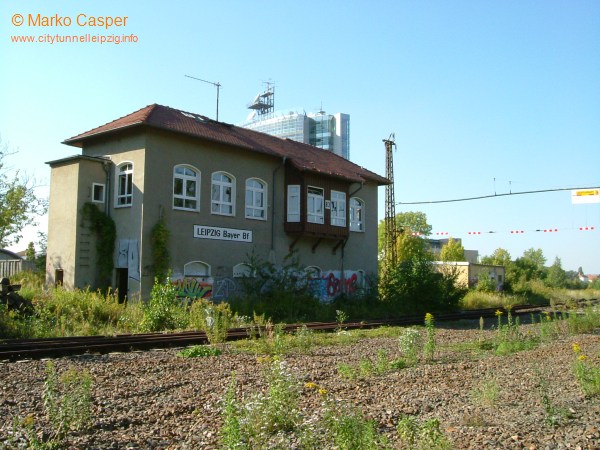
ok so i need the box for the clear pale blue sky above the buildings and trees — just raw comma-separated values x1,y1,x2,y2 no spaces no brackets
0,0,600,273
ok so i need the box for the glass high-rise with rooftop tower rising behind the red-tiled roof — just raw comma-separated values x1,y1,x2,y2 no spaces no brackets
241,86,350,159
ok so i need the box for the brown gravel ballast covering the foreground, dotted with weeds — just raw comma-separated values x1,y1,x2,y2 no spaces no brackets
0,326,600,449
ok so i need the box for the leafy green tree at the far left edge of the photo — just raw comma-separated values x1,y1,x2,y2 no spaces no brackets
0,140,47,247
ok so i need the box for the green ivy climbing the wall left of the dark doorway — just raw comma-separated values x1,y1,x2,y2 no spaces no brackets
81,202,117,285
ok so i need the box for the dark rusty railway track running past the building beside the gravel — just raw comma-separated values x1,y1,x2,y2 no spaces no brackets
0,305,592,361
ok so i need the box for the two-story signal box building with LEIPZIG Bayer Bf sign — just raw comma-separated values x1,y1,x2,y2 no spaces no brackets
46,104,388,298
